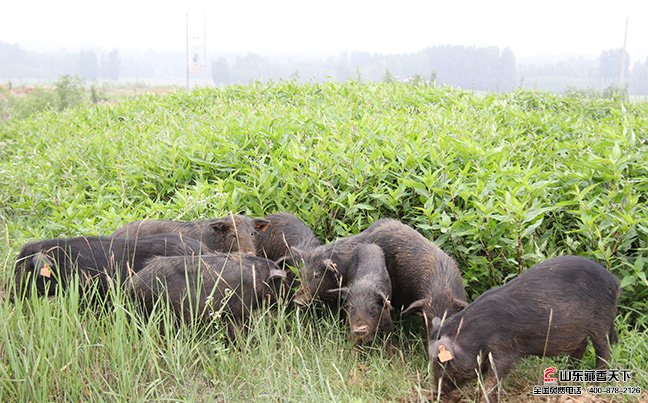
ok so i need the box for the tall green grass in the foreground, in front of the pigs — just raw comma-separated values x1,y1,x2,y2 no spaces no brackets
0,286,648,401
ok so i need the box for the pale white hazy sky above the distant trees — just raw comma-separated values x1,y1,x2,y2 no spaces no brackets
0,0,648,62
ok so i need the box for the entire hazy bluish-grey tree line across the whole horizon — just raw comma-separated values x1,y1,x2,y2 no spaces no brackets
0,42,648,95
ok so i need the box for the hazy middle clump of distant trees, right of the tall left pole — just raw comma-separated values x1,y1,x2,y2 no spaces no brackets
211,46,516,91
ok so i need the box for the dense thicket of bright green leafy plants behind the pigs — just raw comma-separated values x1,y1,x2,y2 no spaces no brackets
0,82,648,318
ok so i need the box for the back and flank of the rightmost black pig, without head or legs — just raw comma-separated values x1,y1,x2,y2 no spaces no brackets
443,256,619,356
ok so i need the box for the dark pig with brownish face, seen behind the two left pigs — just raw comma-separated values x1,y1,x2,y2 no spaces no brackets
110,214,270,254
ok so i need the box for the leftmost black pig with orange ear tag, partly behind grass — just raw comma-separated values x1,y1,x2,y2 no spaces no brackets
15,234,207,296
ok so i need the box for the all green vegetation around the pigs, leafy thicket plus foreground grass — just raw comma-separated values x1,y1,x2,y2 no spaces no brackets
0,82,648,401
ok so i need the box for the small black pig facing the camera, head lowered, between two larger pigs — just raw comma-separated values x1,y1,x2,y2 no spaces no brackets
329,244,394,345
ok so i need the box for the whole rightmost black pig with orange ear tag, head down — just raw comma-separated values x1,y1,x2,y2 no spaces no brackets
428,256,619,399
